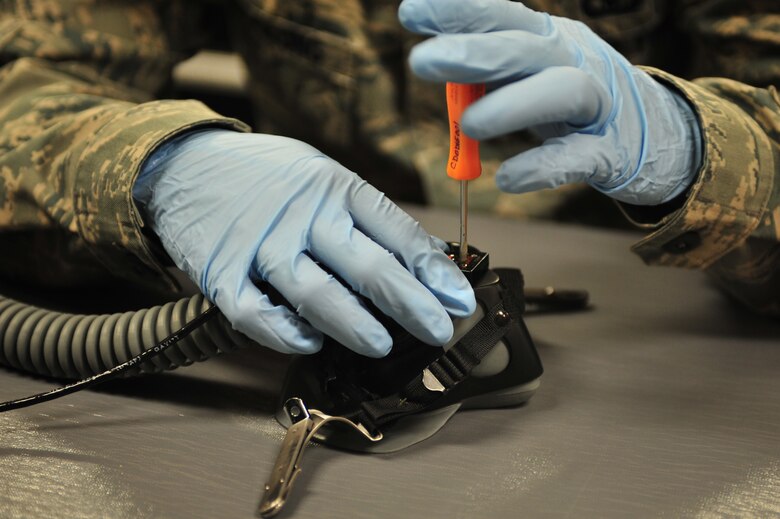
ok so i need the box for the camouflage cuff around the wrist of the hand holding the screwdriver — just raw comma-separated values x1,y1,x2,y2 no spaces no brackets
632,67,775,269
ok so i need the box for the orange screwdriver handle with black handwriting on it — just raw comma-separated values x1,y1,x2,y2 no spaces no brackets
447,83,485,180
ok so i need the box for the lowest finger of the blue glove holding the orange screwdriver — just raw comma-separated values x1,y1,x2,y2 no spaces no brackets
496,133,619,193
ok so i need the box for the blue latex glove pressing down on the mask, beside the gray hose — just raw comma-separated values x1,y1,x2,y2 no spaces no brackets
133,130,476,357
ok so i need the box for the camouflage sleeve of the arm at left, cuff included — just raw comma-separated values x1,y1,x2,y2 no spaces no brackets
0,0,248,285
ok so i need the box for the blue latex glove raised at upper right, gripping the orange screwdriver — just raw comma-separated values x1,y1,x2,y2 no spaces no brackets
399,0,701,205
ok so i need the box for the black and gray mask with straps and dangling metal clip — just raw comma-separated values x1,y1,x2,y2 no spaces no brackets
260,243,543,517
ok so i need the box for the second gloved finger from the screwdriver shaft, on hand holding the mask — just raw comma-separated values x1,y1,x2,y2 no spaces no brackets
311,219,453,345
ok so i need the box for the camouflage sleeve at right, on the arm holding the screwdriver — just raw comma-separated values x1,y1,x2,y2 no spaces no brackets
633,69,780,315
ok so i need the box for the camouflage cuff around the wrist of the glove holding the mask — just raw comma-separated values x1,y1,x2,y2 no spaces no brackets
74,101,250,288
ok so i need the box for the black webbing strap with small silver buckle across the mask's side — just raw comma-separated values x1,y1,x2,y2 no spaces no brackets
346,303,512,431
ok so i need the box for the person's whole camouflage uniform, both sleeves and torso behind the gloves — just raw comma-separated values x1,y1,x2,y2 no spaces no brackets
0,0,780,313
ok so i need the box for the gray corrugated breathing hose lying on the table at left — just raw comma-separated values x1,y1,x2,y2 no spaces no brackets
0,294,255,379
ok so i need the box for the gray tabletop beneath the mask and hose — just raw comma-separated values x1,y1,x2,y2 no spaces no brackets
0,207,780,518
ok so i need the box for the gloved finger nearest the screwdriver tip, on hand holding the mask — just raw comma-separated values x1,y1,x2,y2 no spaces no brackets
350,178,477,317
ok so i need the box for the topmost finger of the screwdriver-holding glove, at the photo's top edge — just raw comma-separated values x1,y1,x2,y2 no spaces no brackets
398,0,550,35
